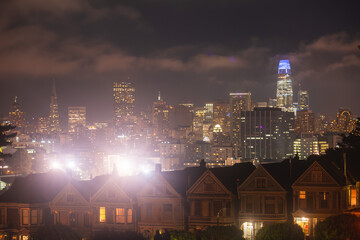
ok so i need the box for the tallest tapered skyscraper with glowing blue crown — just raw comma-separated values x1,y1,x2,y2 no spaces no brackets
276,60,294,112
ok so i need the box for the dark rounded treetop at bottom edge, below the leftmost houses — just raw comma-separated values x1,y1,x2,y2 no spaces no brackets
33,224,81,240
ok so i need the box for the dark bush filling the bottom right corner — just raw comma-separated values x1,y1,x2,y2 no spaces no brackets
315,214,360,240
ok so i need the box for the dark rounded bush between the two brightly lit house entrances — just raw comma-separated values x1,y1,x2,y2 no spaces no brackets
255,221,305,240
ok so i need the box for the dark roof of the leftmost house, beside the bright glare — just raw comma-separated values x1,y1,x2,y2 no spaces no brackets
0,172,69,203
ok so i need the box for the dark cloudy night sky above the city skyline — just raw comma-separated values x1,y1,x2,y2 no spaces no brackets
0,0,360,121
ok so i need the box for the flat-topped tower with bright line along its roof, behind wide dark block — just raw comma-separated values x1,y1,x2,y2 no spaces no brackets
230,92,251,158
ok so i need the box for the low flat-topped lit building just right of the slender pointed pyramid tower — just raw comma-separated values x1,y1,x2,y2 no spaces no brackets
68,107,86,134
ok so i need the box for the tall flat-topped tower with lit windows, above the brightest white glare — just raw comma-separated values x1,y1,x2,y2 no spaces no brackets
113,81,135,129
